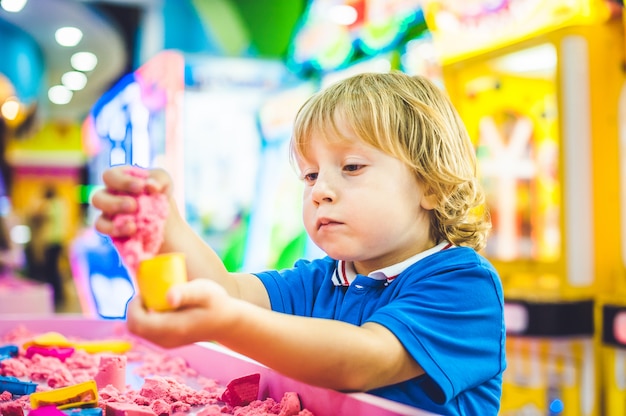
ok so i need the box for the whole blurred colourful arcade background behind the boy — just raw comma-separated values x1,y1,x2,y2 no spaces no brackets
0,0,626,415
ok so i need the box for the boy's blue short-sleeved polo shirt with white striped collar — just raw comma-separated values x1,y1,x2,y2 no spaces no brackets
256,247,506,416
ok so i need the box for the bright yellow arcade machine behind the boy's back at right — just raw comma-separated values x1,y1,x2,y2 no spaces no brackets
425,0,623,416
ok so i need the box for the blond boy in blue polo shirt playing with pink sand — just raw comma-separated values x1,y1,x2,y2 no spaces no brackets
93,72,505,416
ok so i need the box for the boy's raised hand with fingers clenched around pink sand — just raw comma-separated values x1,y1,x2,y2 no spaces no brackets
91,165,172,237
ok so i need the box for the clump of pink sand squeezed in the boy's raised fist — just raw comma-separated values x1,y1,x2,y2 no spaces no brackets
112,167,169,276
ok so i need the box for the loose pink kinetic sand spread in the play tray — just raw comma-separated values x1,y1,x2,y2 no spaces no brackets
0,327,313,416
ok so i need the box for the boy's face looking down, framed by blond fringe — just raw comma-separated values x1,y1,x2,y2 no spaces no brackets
298,114,435,274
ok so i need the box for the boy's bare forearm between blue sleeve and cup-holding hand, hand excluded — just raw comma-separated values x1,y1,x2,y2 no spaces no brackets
221,305,424,391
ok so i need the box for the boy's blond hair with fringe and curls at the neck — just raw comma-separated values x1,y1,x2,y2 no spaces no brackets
291,72,491,250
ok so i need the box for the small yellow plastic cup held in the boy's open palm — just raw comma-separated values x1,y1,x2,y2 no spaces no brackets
136,253,187,311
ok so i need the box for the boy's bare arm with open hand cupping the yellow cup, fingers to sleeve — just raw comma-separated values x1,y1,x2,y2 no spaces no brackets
127,276,423,391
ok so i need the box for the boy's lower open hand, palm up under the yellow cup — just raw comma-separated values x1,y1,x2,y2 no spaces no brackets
126,279,239,348
